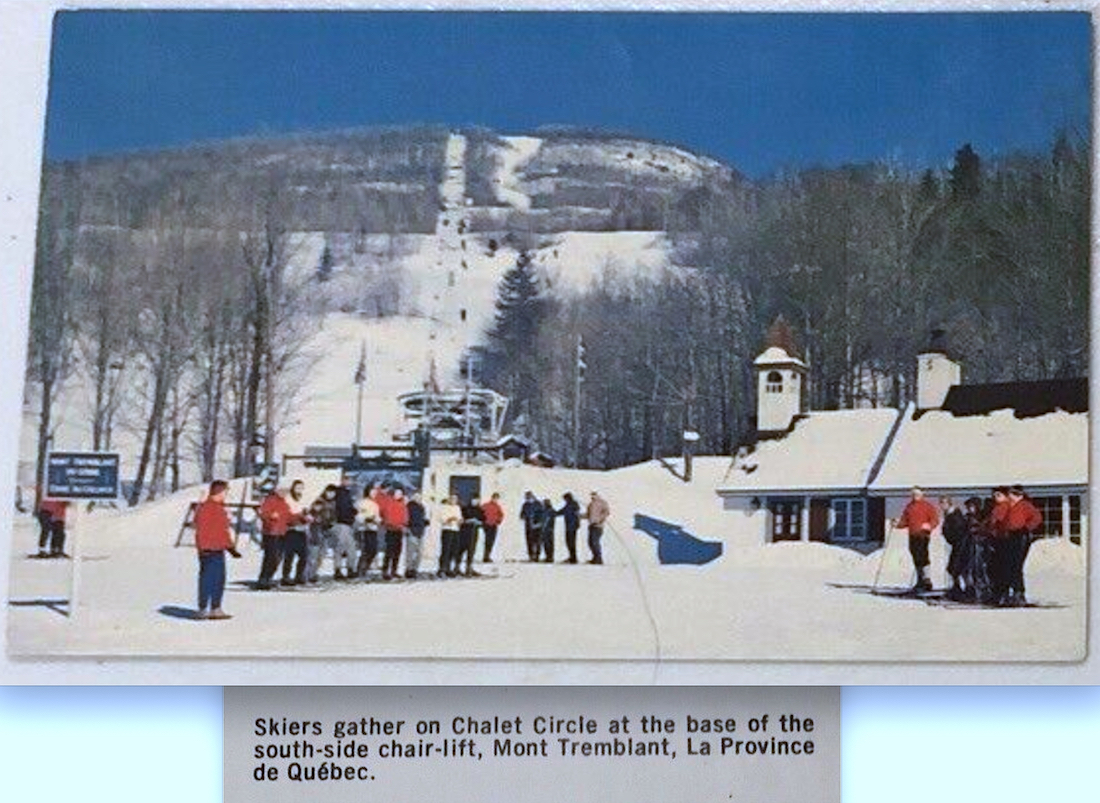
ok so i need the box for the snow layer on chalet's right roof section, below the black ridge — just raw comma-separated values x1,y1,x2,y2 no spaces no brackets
870,402,1089,491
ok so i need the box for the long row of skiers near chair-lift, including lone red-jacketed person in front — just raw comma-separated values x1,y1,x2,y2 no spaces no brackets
194,476,611,619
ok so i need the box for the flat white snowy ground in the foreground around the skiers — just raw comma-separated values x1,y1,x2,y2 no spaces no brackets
9,459,1086,661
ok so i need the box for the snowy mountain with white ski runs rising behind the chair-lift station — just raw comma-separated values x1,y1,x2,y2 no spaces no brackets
20,129,739,485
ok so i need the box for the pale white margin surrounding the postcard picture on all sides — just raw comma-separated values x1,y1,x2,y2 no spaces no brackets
0,0,1100,685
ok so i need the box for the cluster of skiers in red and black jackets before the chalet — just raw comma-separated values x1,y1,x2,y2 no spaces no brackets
892,485,1043,607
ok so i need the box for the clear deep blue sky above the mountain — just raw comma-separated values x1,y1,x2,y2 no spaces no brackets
46,11,1091,176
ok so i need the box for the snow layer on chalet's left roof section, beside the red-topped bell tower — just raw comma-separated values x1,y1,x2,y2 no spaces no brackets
718,408,900,495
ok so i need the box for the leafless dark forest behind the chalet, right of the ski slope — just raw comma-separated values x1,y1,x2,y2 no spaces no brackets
485,132,1090,466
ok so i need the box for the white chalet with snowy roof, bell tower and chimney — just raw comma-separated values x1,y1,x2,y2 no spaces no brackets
717,326,1089,550
